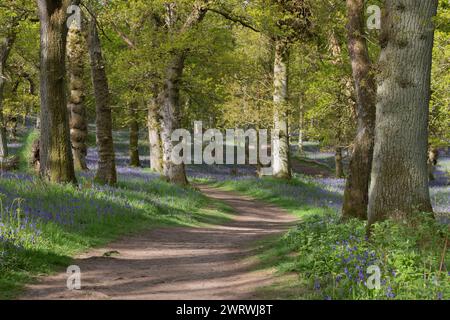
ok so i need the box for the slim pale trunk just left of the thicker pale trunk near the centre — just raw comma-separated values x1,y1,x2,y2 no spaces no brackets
147,90,163,173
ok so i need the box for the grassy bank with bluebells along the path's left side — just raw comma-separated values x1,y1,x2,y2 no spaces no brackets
0,131,236,299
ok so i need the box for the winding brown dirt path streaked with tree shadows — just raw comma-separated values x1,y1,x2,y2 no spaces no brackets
23,186,295,299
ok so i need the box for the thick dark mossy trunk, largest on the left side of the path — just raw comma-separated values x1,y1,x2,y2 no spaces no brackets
38,0,76,183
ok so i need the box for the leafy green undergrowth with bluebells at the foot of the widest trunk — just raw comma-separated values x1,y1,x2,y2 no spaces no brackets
281,214,450,299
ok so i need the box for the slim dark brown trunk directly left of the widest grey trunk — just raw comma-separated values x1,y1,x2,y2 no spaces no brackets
342,0,376,220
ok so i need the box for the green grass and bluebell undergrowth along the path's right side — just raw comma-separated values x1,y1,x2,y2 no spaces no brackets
211,177,450,300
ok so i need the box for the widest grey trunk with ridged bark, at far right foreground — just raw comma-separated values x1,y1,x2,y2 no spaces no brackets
368,0,438,225
